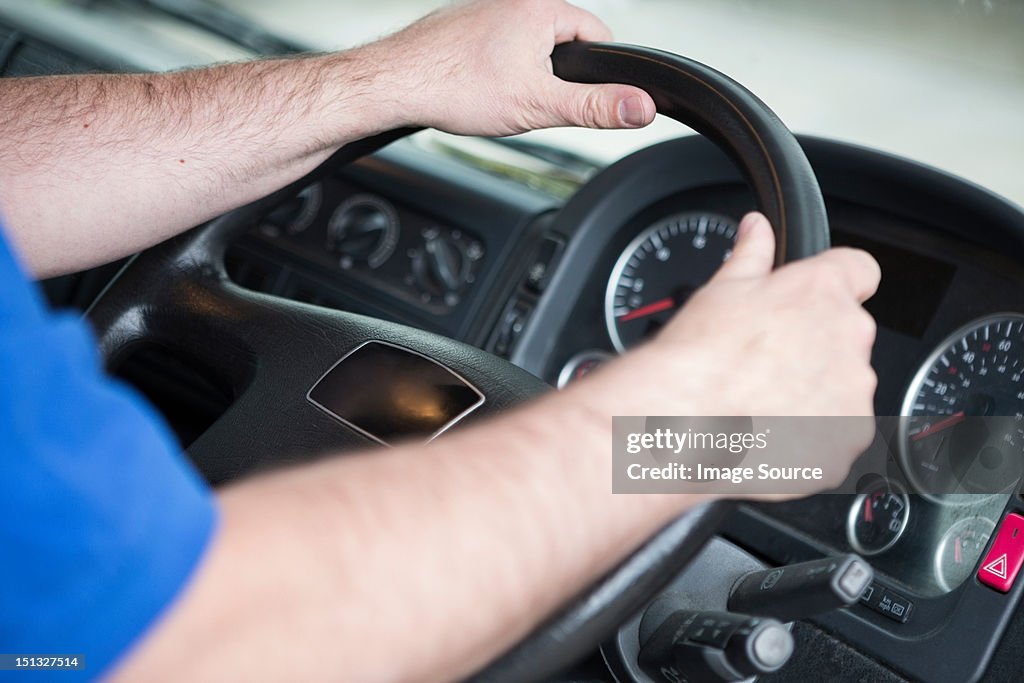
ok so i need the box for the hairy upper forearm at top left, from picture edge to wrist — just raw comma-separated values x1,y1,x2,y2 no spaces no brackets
0,47,398,276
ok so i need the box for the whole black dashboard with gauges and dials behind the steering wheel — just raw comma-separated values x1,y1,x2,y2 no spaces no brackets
216,131,1024,680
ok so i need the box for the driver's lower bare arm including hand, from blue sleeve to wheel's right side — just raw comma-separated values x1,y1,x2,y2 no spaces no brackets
108,215,879,681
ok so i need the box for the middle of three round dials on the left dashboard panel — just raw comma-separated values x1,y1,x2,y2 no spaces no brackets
327,195,399,268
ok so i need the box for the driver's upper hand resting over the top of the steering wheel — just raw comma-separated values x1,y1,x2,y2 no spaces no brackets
368,0,654,135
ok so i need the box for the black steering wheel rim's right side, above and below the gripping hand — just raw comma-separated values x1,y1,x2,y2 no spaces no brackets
470,43,830,683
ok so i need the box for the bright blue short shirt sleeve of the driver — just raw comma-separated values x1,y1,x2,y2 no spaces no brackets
0,229,216,680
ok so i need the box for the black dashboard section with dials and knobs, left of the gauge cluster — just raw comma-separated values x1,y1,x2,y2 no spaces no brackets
227,140,558,346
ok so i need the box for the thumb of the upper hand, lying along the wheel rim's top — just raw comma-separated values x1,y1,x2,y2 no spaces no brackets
551,80,656,128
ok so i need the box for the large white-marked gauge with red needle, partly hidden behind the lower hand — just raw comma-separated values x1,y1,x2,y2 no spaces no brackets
604,213,736,352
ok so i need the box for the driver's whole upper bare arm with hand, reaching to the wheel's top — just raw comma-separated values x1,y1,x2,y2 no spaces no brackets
0,0,654,275
